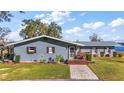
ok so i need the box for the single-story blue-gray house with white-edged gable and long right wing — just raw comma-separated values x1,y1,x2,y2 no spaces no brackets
5,35,120,62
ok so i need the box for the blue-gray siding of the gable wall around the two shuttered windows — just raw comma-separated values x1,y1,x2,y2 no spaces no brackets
14,39,68,62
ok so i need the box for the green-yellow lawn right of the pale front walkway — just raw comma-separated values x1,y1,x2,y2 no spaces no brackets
88,58,124,80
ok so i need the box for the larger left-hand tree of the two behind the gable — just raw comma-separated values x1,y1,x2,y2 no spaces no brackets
20,19,47,39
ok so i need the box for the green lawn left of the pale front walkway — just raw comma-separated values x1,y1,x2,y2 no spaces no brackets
0,64,70,80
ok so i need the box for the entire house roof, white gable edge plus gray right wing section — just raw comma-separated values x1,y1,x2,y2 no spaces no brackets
5,35,121,46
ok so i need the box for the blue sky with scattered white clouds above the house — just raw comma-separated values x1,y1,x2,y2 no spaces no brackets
0,11,124,41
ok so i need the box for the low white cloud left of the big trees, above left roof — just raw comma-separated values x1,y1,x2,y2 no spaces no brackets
6,29,23,41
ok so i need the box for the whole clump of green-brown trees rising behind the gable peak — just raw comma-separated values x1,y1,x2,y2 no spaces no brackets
20,19,62,39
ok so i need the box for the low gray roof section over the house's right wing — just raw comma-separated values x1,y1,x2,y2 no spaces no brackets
78,41,120,46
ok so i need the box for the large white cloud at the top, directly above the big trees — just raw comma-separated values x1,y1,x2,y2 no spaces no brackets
35,11,75,25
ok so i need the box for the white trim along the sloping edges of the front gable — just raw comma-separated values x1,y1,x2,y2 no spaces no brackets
5,35,84,47
